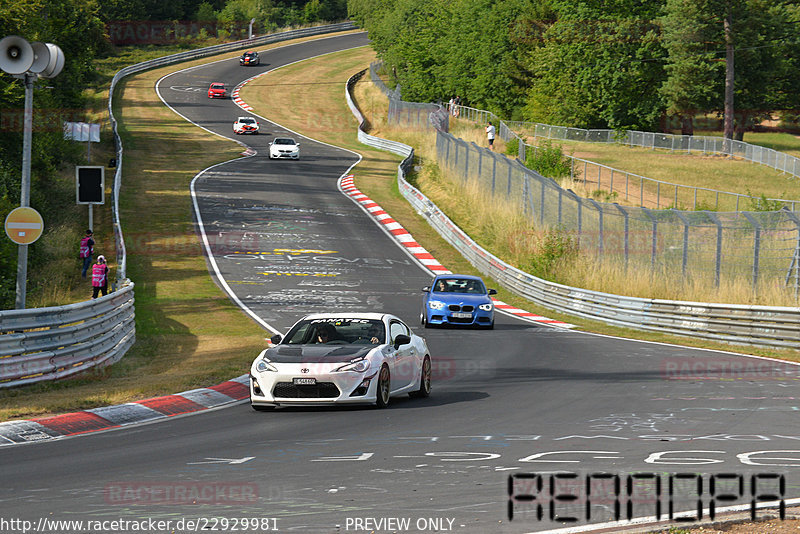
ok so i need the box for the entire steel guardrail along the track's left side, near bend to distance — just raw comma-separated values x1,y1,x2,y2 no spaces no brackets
0,22,356,388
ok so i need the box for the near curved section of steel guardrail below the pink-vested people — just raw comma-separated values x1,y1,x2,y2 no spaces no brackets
0,283,136,388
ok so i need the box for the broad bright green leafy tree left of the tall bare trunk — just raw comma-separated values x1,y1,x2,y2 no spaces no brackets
518,0,664,129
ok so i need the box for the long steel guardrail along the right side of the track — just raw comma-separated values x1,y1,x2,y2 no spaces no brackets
347,73,800,348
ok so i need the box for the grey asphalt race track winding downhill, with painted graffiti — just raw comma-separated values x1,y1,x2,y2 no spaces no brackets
0,34,800,533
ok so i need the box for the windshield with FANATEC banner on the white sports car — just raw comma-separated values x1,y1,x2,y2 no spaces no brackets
281,317,386,345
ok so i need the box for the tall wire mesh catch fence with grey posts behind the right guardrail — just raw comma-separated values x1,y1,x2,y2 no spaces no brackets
370,64,800,298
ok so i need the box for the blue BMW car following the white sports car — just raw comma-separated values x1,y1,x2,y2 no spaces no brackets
420,274,497,328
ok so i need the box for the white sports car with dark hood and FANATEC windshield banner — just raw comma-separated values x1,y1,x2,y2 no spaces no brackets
250,313,431,410
